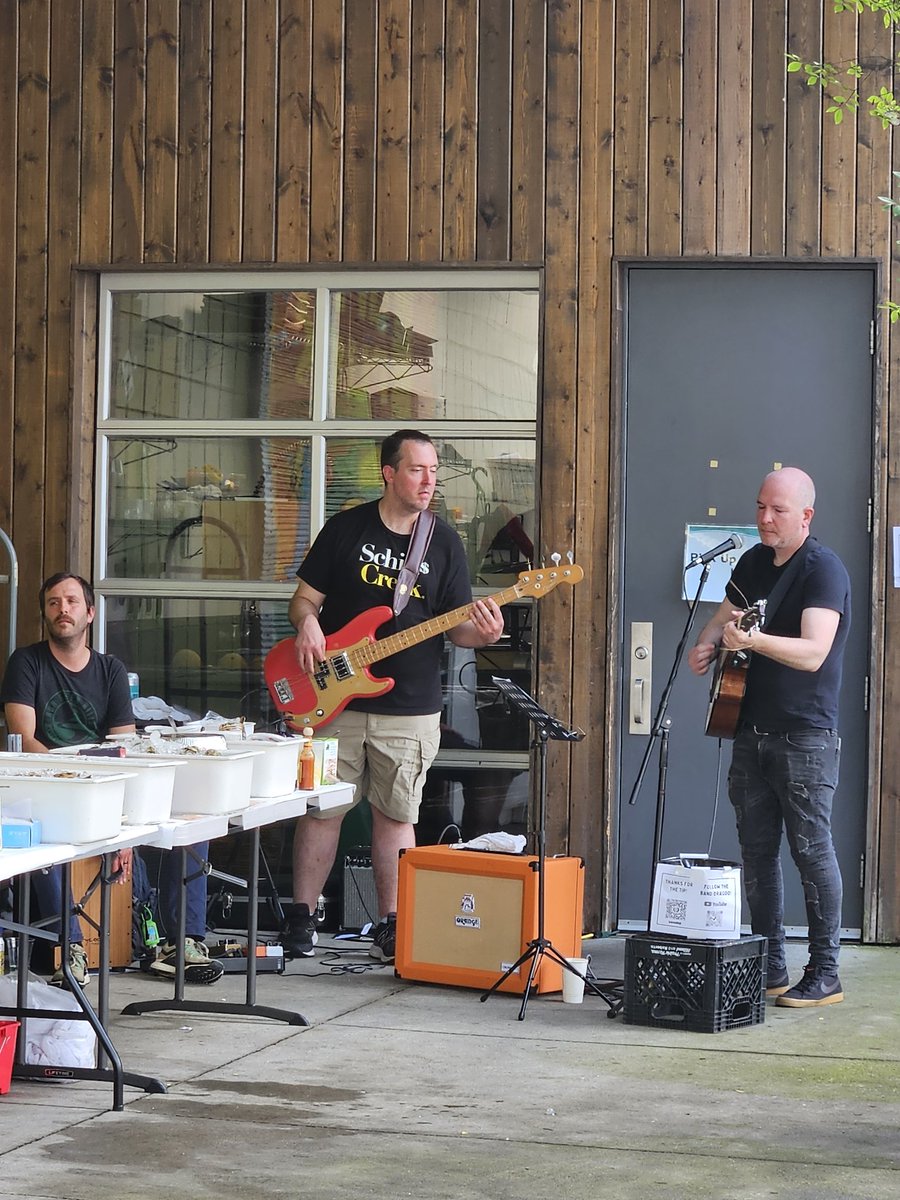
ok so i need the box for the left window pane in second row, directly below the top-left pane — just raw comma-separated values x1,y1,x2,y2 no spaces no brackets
104,437,310,582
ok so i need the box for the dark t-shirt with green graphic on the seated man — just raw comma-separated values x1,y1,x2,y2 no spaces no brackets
0,642,134,750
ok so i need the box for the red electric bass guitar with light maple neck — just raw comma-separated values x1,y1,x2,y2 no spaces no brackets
263,563,584,730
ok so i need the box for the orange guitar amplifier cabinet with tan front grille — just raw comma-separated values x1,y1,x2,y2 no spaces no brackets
394,846,584,996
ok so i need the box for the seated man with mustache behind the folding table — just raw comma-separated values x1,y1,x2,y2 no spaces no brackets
0,571,222,985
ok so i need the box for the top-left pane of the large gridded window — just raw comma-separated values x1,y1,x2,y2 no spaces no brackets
109,292,316,421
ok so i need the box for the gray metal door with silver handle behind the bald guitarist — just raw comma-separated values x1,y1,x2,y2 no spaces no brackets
617,264,875,934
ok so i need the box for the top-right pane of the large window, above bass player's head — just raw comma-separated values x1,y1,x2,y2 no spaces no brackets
329,290,538,425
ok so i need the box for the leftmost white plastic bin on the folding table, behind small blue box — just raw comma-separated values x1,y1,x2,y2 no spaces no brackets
0,760,127,844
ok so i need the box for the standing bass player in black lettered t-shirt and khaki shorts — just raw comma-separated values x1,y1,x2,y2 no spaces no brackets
282,430,503,962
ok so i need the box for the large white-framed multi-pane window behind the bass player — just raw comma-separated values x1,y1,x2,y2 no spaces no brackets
95,271,539,829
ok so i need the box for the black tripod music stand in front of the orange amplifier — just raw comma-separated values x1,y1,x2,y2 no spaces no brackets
481,676,618,1021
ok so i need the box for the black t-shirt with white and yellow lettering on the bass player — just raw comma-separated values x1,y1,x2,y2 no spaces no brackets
296,500,472,716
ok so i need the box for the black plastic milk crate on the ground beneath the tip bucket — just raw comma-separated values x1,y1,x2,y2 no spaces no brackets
623,934,768,1033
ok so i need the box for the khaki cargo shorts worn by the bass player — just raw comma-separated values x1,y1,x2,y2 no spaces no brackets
308,709,440,824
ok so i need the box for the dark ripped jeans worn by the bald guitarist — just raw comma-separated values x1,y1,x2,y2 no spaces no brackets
728,728,842,973
